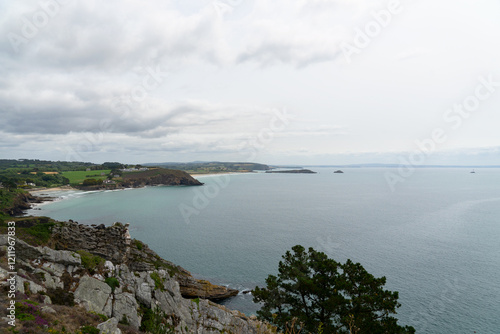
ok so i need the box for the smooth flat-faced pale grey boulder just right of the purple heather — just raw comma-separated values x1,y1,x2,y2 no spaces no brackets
75,276,112,317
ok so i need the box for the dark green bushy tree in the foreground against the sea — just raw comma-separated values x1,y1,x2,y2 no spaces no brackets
253,245,415,334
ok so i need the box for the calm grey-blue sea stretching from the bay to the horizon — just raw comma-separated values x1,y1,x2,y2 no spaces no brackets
30,168,500,333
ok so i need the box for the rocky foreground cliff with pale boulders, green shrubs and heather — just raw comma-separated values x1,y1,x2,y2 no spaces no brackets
0,222,276,334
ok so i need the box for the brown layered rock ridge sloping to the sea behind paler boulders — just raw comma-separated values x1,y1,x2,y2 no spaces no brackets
51,221,238,301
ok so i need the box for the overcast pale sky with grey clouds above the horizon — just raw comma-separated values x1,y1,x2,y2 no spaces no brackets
0,0,500,165
